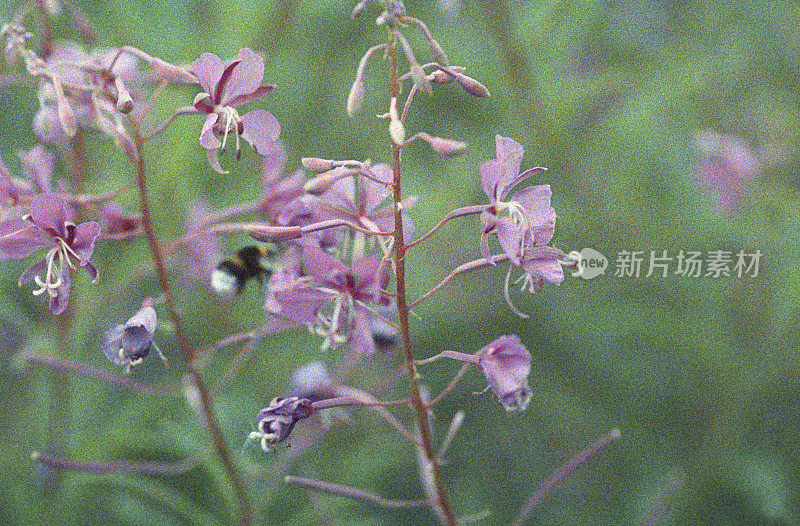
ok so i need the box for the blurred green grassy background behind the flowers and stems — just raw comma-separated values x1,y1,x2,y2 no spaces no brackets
0,0,800,525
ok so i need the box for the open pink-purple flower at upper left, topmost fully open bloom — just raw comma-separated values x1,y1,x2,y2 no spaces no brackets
192,48,281,173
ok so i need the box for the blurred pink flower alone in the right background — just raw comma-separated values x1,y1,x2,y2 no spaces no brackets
694,131,763,213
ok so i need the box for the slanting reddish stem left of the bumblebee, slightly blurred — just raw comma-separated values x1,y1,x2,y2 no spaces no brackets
133,126,253,526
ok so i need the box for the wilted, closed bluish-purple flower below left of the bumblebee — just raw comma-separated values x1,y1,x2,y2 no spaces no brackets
103,305,157,373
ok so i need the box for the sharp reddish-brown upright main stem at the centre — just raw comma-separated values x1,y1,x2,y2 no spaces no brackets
387,38,458,526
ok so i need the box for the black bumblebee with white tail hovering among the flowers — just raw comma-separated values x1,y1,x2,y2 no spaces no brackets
211,243,280,296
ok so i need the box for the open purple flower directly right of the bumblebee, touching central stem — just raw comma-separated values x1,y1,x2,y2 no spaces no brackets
266,245,380,355
